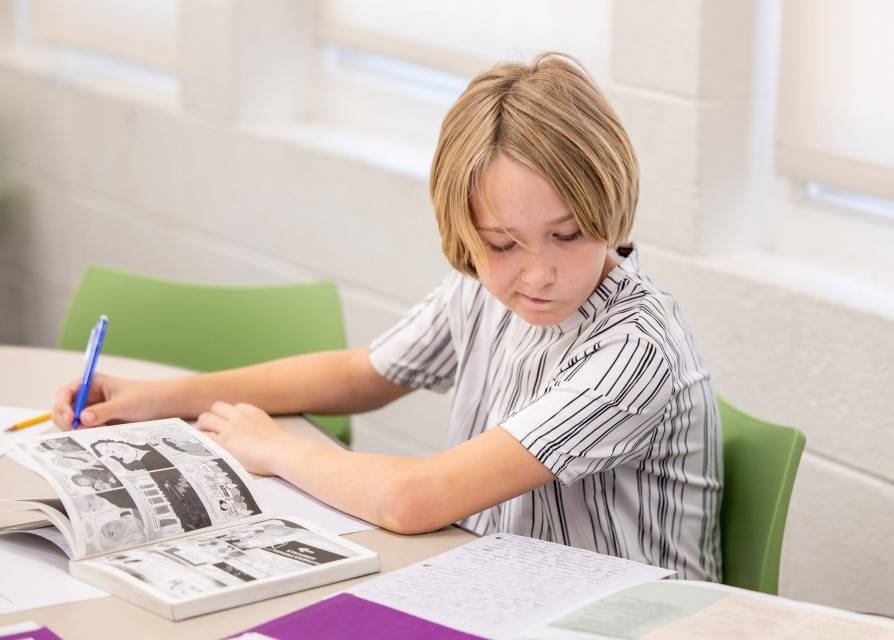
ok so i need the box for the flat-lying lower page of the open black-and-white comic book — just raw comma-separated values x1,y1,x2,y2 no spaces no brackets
72,518,378,602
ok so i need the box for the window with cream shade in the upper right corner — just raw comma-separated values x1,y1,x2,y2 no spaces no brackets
776,0,894,200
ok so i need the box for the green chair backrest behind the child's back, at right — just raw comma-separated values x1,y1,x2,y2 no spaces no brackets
717,398,806,595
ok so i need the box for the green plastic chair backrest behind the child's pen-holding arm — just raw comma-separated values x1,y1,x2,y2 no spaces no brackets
58,265,350,443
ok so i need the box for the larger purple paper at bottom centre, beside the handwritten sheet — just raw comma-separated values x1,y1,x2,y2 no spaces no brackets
231,593,482,640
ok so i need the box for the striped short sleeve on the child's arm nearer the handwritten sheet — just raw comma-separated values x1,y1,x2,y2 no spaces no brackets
500,334,672,485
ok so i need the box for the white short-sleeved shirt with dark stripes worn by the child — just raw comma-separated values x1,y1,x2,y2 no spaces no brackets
370,245,722,580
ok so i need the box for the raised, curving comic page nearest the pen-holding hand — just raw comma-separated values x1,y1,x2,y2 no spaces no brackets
16,419,263,558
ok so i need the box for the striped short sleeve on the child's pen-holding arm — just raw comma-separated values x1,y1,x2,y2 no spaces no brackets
370,276,457,392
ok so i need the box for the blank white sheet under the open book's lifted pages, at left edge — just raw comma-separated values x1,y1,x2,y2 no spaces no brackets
0,533,107,614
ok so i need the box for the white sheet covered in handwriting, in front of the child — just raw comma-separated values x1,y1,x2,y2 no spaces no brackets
348,534,673,639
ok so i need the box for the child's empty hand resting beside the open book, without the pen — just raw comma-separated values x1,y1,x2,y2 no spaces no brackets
196,402,298,476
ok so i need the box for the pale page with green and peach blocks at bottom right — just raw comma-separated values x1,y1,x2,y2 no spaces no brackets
522,580,894,640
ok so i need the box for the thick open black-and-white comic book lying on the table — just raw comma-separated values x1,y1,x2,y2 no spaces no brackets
0,419,379,620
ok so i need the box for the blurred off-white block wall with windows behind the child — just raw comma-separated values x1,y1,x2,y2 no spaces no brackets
0,0,894,614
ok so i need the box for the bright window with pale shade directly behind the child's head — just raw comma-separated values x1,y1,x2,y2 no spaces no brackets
305,0,612,154
